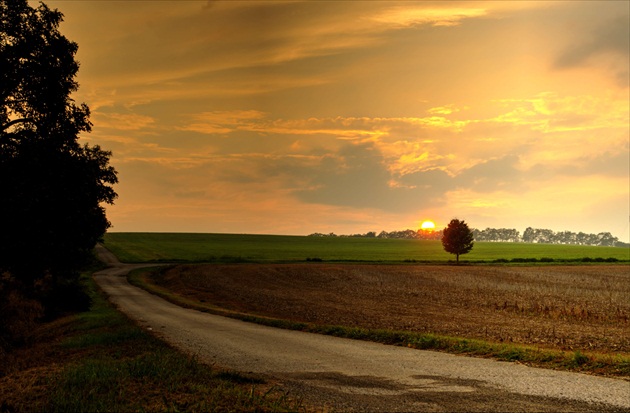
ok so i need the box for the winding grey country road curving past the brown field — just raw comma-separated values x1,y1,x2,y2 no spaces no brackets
94,246,630,412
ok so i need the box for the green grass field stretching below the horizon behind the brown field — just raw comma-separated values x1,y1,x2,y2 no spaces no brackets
104,232,630,263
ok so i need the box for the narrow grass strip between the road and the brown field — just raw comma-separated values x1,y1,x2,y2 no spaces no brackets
129,269,630,378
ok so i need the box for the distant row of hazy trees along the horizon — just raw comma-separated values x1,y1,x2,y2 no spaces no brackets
309,227,630,247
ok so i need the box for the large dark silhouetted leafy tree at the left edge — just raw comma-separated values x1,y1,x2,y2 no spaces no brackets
0,0,118,306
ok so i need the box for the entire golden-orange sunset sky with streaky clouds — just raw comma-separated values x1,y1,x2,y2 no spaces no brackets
42,0,630,238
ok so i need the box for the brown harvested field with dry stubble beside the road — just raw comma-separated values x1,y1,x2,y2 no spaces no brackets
153,263,630,355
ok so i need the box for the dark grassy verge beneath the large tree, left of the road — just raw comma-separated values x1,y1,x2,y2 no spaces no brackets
0,275,305,412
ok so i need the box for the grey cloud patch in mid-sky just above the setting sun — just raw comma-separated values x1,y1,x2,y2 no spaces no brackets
286,142,524,212
